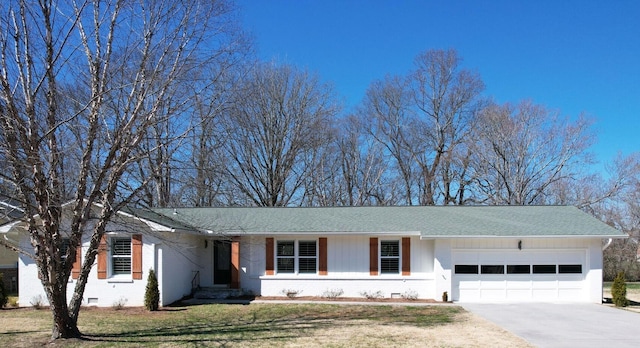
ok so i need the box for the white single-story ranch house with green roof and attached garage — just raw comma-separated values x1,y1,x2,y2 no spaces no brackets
0,206,626,306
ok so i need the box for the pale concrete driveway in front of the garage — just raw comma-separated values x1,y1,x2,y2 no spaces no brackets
459,303,640,348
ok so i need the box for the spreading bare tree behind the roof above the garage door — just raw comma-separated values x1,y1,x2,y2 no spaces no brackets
472,101,593,205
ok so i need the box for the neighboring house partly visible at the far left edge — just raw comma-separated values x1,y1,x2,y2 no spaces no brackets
0,199,22,293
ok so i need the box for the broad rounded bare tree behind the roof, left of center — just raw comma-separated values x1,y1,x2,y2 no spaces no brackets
225,64,338,206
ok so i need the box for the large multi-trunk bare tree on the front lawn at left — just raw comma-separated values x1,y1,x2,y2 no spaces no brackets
0,0,245,339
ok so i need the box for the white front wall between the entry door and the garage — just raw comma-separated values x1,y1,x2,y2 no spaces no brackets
248,235,435,298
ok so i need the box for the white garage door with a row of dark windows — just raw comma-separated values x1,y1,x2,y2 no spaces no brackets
452,250,586,302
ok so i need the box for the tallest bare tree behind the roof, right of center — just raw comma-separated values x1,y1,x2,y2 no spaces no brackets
411,50,484,205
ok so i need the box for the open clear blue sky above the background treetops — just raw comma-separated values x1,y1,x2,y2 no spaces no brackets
238,0,640,169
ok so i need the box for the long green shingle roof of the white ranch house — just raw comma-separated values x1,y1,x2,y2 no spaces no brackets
136,206,626,238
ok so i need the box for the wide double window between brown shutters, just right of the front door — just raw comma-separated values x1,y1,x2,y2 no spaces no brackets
276,240,318,273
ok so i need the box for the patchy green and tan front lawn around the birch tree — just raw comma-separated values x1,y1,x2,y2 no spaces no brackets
0,304,463,347
